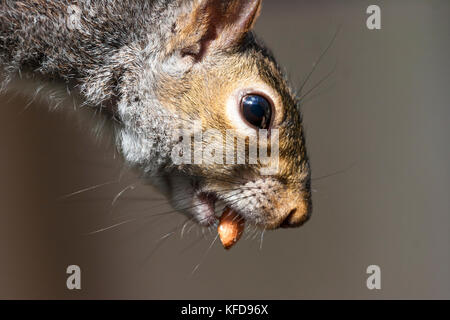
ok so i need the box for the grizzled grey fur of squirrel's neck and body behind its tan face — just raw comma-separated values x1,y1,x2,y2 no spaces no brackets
0,0,185,171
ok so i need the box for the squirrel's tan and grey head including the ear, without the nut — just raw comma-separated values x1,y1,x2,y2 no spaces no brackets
117,0,311,229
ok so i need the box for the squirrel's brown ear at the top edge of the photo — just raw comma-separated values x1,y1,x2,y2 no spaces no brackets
170,0,262,61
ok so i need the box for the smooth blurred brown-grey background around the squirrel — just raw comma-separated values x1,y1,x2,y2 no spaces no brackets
0,0,450,299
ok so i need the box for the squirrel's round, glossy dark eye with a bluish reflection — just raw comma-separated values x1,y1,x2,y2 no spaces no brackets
241,95,272,129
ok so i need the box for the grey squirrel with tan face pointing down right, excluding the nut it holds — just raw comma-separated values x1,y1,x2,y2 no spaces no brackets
0,0,312,240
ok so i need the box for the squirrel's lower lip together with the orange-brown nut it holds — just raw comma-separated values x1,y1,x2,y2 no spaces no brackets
195,192,245,249
